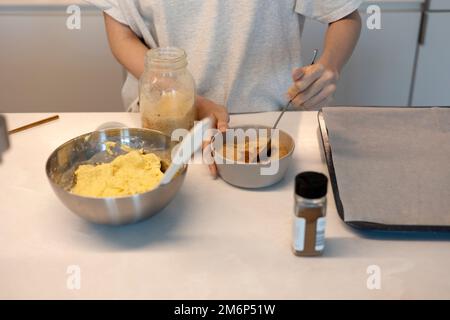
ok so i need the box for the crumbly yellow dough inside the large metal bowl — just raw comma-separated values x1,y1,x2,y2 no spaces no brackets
72,150,164,198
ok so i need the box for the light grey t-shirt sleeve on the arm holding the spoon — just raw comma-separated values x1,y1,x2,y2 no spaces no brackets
295,0,362,23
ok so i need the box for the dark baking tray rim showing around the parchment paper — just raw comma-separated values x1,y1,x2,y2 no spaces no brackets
317,107,450,233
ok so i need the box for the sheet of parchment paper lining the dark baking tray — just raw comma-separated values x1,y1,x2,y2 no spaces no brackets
323,107,450,226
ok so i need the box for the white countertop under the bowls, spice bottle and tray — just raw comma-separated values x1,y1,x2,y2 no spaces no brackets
0,112,450,299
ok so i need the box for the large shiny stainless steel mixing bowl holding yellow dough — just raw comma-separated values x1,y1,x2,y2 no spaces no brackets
46,128,187,225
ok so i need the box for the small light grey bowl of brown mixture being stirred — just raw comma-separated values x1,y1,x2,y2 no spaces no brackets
212,125,295,189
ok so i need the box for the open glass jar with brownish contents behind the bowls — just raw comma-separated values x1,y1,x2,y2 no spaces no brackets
139,47,197,136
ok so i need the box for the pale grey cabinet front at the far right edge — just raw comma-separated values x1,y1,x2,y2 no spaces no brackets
412,1,450,106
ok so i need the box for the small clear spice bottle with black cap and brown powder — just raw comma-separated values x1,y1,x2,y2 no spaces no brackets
293,172,328,256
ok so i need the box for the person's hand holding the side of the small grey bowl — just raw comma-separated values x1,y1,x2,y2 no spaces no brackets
195,96,230,178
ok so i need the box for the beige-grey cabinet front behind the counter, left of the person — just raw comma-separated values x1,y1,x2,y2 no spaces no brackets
0,5,124,112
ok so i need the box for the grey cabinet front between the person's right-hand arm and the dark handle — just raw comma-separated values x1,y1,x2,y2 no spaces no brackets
302,1,421,106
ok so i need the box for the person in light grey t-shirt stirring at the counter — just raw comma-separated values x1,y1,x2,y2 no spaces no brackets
86,0,362,174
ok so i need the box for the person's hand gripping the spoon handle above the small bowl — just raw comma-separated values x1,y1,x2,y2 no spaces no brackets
287,62,339,110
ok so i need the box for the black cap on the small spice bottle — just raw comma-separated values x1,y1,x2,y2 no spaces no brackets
295,172,328,199
